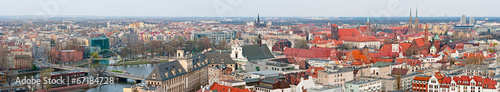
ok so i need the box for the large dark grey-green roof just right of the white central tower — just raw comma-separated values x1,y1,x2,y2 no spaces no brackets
242,44,274,60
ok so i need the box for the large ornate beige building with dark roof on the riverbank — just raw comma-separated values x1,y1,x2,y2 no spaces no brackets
127,51,213,92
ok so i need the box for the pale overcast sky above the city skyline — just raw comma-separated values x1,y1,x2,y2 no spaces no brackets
0,0,500,17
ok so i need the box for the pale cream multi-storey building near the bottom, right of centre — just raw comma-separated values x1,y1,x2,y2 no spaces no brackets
316,68,354,86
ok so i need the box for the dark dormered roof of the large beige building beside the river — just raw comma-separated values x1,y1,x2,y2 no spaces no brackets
146,60,187,81
